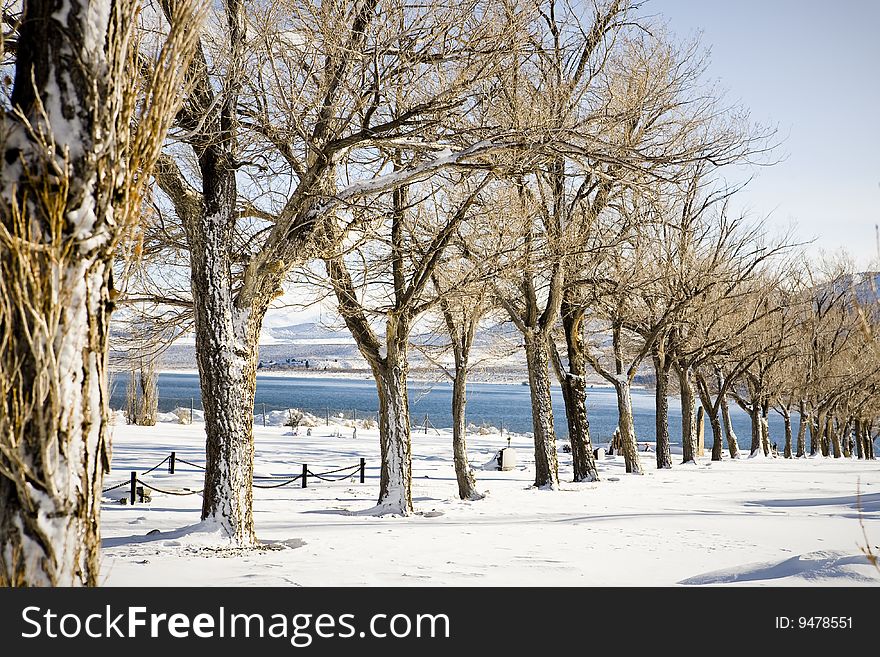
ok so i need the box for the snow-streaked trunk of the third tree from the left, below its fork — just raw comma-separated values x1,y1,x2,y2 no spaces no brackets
374,344,413,515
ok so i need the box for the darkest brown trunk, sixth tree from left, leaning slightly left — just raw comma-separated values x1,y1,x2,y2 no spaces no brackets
550,308,599,481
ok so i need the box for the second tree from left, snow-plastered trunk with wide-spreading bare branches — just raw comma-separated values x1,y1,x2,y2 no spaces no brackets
150,0,516,545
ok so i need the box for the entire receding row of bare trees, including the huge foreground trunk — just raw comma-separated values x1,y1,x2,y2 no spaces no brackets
0,0,877,584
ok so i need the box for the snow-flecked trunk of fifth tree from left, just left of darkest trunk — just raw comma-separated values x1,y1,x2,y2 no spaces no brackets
524,329,559,489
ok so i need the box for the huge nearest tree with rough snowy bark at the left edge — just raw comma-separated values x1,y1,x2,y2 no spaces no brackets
0,0,199,586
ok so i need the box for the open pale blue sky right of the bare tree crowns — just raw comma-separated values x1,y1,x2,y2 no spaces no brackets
641,0,880,265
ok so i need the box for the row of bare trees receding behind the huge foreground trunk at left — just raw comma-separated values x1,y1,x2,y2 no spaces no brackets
127,0,880,544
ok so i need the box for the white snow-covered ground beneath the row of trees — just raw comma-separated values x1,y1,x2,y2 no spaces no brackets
102,416,880,586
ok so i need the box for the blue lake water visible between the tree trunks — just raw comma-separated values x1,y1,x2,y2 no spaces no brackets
110,373,798,449
